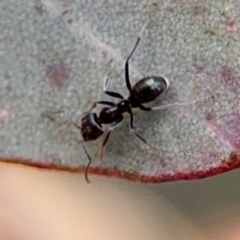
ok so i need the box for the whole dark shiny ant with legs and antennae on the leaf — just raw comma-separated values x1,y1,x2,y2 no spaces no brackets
49,4,169,183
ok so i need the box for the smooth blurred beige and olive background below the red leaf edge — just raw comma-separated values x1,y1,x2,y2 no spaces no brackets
0,163,240,240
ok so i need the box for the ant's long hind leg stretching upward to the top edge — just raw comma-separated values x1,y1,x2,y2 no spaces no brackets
125,3,157,92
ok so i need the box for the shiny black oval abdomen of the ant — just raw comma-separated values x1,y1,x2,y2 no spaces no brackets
130,76,169,107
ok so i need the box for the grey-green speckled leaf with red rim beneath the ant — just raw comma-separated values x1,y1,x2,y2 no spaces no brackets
0,0,240,183
